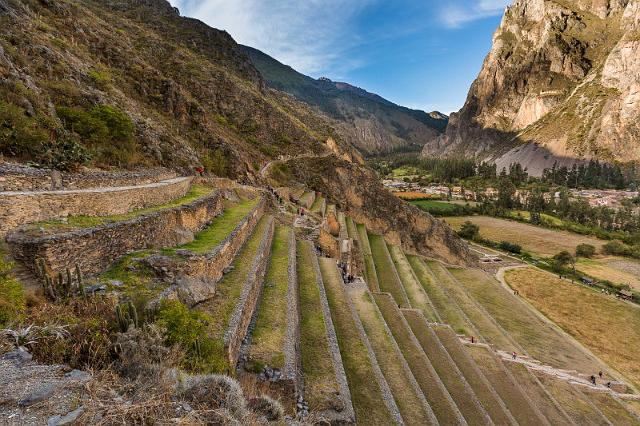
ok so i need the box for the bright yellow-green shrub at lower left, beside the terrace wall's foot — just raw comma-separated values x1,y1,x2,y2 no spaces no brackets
158,300,229,372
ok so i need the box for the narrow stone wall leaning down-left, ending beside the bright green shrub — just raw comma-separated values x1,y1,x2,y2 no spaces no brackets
224,217,275,368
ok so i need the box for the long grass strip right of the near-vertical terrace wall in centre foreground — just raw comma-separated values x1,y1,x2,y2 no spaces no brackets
297,241,340,411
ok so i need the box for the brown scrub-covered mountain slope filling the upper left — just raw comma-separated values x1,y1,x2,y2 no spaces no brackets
0,0,468,263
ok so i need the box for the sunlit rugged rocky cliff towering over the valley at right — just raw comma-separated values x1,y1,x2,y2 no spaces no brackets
424,0,640,174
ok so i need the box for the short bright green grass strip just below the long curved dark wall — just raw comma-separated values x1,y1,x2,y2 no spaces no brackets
171,198,259,254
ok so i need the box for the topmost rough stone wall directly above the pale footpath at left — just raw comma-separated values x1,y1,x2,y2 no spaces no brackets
0,162,177,191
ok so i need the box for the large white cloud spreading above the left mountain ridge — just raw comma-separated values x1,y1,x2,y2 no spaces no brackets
171,0,376,75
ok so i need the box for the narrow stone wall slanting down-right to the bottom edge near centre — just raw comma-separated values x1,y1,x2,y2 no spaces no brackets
309,242,356,424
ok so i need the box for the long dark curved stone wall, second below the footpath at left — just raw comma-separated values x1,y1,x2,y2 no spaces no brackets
7,191,224,275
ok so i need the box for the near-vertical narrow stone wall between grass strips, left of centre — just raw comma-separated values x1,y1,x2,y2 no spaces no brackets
282,230,303,397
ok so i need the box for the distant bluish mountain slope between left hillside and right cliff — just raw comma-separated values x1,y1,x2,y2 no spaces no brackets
243,46,447,154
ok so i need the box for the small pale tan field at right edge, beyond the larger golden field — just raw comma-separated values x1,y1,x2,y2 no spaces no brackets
576,256,640,291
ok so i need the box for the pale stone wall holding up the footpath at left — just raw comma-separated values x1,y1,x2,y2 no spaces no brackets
0,177,192,237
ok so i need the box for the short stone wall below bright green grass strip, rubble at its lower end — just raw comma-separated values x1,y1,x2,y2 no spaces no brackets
174,198,267,292
